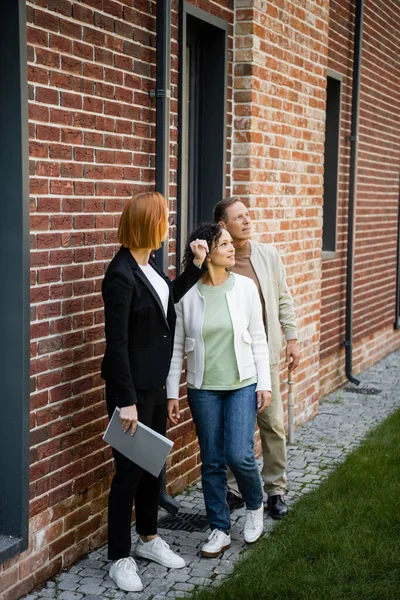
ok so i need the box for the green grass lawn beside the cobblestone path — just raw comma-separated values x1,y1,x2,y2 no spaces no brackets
191,411,400,600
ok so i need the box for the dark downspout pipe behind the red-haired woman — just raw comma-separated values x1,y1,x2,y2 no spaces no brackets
151,0,180,514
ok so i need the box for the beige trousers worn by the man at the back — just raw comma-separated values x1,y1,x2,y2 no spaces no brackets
228,363,286,496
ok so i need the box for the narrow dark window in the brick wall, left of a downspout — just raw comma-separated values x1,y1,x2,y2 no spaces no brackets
322,71,342,258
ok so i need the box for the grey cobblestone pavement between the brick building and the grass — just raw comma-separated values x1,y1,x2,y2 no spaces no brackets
24,351,400,600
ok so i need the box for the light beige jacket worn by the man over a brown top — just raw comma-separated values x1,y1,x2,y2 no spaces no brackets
250,242,297,365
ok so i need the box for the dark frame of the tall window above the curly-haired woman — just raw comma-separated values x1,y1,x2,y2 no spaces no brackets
176,0,229,272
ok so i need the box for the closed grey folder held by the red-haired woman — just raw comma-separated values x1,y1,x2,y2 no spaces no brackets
103,407,174,477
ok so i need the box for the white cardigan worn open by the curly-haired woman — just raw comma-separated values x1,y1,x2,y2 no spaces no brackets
167,274,271,398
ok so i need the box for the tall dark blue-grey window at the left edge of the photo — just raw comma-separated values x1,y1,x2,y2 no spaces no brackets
0,0,29,563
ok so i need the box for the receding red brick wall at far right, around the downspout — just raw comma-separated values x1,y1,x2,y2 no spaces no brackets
320,0,400,394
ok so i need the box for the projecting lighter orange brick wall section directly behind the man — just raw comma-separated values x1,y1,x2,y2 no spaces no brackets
233,0,328,423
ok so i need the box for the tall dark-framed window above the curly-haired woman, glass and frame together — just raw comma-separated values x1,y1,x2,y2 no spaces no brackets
177,2,228,262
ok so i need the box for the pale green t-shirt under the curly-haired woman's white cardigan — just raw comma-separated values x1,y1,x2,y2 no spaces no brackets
190,275,257,390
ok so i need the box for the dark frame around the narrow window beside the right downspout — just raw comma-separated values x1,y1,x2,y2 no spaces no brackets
322,69,343,260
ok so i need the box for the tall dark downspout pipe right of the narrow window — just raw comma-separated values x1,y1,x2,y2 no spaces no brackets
344,0,364,385
